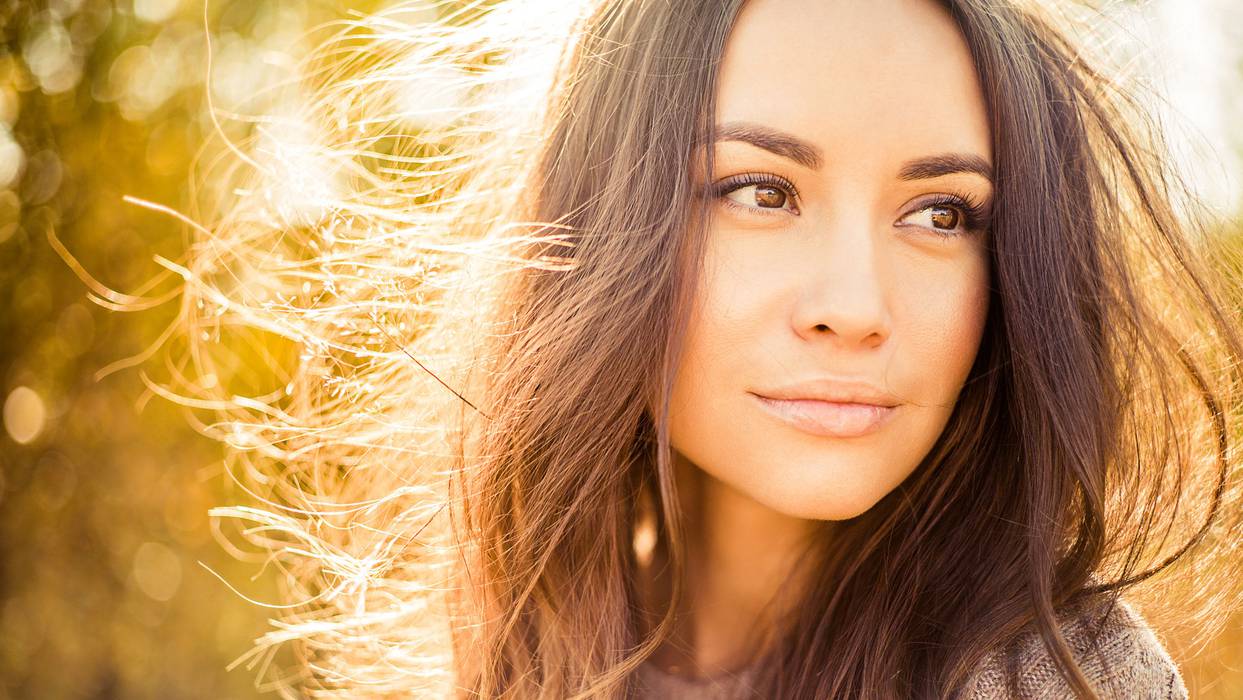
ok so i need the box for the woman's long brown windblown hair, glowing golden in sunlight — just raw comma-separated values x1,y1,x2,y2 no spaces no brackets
128,0,1243,699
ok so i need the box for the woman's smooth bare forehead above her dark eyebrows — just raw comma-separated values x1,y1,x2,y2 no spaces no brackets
716,0,991,168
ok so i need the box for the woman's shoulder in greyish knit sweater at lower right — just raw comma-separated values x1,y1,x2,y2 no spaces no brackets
963,599,1187,700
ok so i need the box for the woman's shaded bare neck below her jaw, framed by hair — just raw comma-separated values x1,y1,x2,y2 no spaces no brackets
648,453,824,675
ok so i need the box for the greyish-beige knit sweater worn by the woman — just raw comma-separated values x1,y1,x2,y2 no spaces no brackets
638,601,1187,700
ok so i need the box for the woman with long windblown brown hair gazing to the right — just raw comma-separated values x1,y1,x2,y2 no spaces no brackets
160,0,1243,698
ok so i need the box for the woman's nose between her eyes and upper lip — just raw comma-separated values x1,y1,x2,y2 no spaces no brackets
792,211,891,349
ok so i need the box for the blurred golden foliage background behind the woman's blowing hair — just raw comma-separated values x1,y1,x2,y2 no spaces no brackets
0,0,1243,700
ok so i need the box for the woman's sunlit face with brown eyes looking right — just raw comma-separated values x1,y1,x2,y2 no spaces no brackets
670,0,992,520
